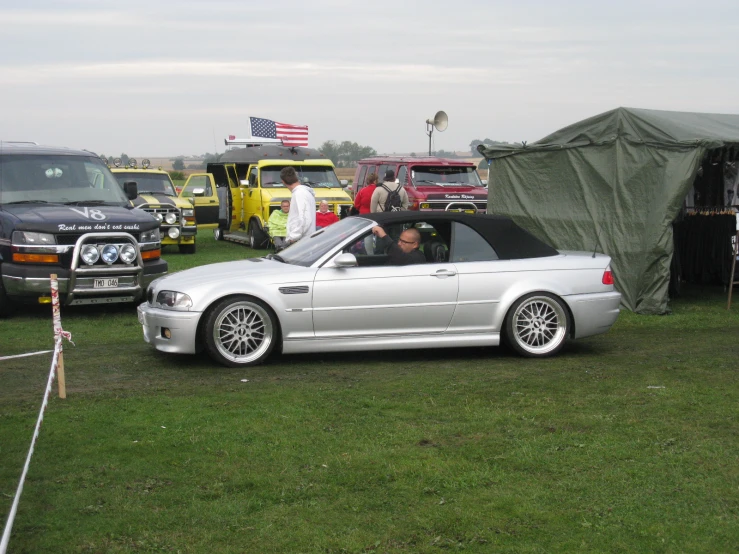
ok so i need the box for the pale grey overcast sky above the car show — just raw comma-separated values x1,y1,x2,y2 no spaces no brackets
0,0,739,157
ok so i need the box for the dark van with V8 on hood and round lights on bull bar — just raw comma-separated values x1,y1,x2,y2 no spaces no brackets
0,141,167,315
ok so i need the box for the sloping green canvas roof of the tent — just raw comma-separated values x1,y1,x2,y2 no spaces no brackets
478,108,739,159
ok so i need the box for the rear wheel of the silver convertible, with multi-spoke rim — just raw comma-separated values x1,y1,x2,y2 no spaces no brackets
504,292,571,358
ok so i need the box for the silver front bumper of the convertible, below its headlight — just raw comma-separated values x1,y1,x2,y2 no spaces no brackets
137,302,203,354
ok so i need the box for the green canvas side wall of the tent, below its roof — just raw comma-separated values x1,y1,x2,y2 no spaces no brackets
488,140,702,314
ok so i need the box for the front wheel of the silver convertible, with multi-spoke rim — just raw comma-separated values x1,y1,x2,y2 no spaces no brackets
203,295,279,367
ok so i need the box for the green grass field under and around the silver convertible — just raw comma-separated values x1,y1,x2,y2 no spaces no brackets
0,235,739,553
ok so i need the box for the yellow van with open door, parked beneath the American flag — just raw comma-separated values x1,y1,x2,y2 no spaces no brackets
188,144,353,248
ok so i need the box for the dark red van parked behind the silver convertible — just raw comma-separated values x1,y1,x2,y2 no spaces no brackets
352,156,488,213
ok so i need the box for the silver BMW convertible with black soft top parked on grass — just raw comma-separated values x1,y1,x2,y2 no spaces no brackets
138,211,621,367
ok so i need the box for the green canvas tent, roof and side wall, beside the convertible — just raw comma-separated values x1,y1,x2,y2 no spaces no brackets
479,108,739,314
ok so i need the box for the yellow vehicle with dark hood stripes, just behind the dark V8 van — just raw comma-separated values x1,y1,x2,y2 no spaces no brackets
111,162,217,254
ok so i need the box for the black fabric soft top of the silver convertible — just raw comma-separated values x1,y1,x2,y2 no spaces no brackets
355,211,559,260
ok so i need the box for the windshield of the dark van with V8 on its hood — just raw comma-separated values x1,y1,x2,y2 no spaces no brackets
0,154,129,205
